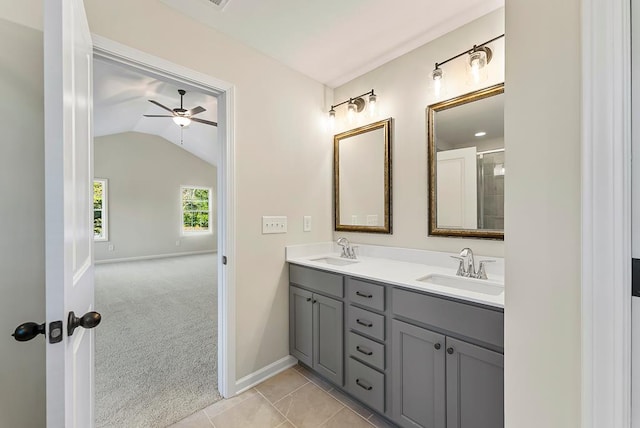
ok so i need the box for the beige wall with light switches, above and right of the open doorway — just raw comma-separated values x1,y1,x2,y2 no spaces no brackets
0,0,333,402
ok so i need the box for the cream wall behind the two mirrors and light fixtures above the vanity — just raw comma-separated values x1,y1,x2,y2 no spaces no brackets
334,9,504,258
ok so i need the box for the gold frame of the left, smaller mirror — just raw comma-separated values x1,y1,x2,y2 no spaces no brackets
333,118,392,234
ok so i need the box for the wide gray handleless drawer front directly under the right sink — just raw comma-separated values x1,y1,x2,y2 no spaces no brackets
392,288,504,348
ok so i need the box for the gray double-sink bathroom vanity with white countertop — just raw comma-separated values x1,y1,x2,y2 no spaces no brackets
287,247,504,428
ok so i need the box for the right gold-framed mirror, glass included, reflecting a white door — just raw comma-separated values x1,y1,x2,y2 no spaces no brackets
427,83,505,239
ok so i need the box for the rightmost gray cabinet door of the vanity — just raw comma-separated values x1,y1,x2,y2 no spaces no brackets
447,337,504,428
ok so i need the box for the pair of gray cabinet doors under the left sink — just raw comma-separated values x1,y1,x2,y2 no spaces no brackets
289,286,344,386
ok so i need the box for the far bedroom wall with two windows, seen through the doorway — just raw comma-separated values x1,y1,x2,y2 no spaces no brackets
94,132,217,261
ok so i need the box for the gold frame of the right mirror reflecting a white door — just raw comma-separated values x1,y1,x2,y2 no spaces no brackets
427,83,504,240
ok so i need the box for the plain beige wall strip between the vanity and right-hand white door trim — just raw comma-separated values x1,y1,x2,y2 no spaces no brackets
505,0,581,428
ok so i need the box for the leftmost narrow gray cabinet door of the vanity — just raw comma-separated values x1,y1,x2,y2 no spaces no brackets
289,287,313,367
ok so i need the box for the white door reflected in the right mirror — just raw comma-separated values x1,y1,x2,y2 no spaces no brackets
436,147,478,229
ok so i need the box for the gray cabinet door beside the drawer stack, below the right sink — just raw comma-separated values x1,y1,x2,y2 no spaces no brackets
391,320,446,428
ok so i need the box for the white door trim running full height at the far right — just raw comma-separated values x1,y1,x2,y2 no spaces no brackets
578,0,632,428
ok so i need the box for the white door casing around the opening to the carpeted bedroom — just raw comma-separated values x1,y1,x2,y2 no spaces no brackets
94,39,235,424
